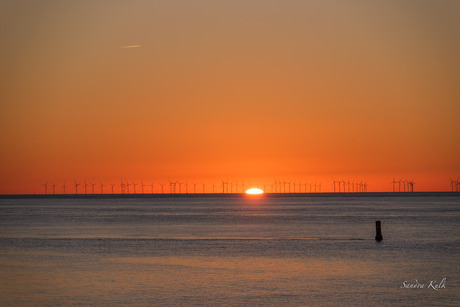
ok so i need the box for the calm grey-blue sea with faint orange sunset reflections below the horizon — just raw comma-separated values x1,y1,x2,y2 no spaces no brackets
0,194,460,306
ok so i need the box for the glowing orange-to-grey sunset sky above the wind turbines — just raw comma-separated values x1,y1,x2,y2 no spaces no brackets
0,0,460,193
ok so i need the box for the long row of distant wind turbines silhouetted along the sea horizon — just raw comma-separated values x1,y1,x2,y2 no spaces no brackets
36,177,460,195
